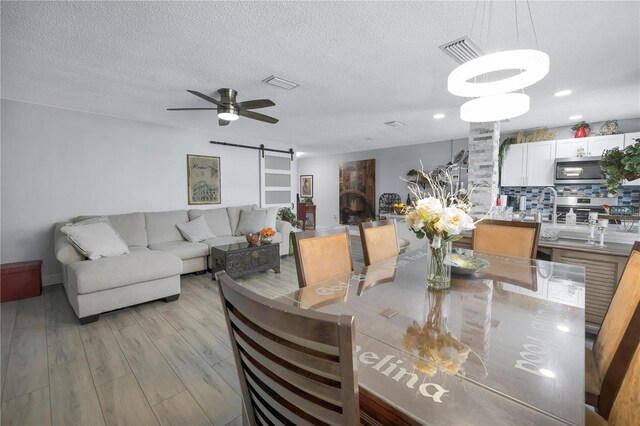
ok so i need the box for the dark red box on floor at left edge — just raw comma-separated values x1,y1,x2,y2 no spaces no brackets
0,260,42,302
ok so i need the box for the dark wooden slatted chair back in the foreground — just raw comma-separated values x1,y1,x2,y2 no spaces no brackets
216,271,360,426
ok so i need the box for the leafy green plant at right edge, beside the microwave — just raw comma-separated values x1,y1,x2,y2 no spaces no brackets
600,138,640,195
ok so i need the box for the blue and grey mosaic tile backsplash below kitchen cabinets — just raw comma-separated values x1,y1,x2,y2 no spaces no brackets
500,185,640,210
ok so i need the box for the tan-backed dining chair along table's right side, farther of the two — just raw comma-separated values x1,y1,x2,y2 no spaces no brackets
585,241,640,413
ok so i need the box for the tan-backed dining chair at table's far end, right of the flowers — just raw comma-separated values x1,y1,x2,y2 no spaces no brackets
472,220,540,259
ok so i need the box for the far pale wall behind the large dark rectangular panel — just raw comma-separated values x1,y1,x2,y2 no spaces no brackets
298,139,469,226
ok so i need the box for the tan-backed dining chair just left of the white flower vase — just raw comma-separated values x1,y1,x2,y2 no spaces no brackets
360,219,400,266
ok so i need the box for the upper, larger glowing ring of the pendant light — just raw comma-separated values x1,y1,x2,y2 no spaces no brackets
447,49,549,98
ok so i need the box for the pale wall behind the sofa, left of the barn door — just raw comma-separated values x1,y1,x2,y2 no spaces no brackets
0,100,295,284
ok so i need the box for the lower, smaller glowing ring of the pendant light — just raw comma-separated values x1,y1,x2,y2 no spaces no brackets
460,93,530,123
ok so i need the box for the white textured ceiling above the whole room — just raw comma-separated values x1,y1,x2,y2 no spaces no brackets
1,1,640,153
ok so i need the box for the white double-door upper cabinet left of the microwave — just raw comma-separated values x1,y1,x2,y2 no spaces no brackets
501,141,556,186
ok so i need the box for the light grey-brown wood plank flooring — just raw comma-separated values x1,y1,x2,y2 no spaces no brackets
0,237,363,425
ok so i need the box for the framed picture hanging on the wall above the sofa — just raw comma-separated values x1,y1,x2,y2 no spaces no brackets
187,154,221,204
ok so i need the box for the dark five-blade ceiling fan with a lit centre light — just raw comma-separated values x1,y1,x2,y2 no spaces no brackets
167,88,278,126
